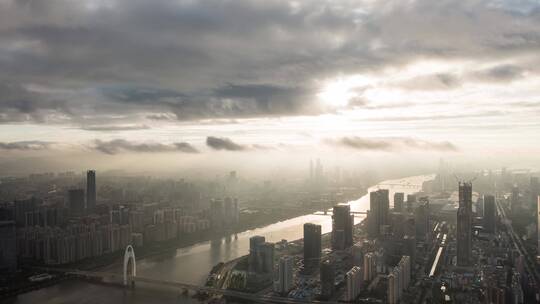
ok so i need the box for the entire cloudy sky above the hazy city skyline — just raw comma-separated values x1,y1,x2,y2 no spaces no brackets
0,0,540,174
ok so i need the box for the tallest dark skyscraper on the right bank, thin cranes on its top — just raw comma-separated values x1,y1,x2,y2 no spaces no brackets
457,182,472,266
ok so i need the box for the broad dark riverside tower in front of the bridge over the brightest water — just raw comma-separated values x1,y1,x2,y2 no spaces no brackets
332,205,353,250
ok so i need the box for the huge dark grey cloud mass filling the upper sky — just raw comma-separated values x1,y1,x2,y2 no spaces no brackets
0,0,540,125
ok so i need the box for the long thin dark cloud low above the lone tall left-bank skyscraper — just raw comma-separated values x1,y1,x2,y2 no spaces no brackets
93,139,199,155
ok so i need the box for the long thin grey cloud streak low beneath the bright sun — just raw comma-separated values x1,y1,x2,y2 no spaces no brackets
324,136,458,152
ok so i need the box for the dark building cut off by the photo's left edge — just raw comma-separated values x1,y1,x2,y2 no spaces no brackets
0,221,17,273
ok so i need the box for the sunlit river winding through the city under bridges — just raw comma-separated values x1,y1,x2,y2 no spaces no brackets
10,175,433,304
